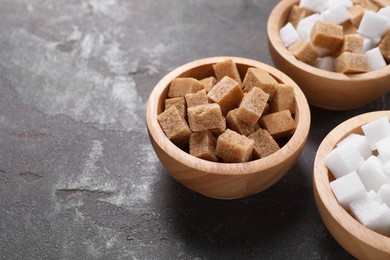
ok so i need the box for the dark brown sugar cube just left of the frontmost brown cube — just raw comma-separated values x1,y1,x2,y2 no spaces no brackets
190,131,218,162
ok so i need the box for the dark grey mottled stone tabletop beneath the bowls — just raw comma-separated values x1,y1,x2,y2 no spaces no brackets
0,0,390,259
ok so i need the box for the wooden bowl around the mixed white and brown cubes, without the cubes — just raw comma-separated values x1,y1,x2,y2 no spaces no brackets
267,0,390,110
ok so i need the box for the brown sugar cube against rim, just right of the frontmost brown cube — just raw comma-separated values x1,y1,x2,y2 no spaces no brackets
248,129,280,159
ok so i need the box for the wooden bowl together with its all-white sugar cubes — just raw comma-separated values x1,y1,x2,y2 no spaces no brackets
313,111,390,259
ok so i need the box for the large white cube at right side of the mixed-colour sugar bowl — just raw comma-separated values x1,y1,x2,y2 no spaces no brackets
358,10,388,39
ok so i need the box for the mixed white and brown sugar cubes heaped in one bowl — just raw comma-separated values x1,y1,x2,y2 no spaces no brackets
279,0,390,74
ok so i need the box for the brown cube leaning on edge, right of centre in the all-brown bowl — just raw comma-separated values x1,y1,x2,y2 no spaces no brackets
237,88,269,125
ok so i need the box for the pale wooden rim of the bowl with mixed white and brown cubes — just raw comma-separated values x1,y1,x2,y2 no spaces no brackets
267,0,390,81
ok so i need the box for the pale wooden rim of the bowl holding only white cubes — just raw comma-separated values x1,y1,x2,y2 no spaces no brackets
313,110,390,255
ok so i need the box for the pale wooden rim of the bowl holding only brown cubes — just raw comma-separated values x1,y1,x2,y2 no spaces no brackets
146,56,310,175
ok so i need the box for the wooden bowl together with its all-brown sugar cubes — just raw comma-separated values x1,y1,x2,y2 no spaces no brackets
146,57,310,199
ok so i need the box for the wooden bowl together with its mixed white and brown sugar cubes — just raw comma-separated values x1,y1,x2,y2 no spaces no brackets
267,0,390,110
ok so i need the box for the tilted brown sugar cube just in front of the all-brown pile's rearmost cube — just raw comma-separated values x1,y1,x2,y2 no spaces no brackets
207,76,244,115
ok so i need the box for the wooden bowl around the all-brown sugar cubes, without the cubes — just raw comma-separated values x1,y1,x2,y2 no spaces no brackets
146,57,310,199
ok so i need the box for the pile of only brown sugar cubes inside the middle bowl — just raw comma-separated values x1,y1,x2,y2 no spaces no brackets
157,59,296,163
